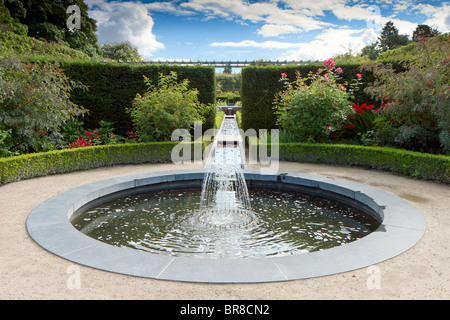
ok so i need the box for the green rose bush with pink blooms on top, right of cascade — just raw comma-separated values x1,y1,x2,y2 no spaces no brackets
275,59,358,142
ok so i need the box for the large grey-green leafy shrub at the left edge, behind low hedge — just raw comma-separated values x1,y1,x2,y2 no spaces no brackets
0,57,85,153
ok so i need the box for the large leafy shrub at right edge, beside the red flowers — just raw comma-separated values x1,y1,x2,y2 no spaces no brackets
366,34,450,154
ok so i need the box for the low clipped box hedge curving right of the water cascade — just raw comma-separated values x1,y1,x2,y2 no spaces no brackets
279,143,450,184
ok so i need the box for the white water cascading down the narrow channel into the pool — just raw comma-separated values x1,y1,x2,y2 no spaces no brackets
196,116,256,229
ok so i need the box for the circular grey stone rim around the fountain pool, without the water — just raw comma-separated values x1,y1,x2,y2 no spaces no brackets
26,169,426,283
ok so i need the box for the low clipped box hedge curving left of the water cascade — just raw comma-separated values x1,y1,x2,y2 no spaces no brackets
0,142,178,185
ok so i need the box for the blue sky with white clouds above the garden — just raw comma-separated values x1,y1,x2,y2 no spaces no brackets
85,0,450,61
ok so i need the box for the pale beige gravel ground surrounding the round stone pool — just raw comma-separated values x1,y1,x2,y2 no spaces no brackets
0,162,450,300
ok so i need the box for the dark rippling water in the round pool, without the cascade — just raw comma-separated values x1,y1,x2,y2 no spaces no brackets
72,188,379,259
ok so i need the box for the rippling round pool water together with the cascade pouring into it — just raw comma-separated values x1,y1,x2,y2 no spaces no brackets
71,117,379,259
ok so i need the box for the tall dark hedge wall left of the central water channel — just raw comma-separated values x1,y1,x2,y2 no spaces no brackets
61,62,216,134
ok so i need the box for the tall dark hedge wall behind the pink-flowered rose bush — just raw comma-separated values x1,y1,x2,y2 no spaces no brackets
241,64,373,130
